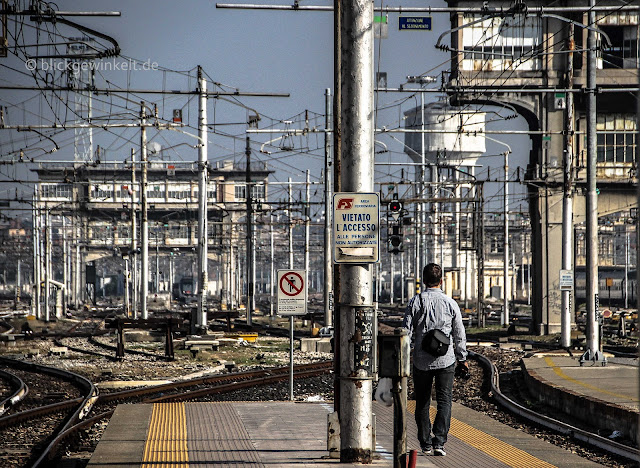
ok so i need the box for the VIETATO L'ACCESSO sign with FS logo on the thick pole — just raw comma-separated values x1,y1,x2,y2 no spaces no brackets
333,192,380,263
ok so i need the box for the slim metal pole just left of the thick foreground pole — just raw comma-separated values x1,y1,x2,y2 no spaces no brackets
323,88,333,327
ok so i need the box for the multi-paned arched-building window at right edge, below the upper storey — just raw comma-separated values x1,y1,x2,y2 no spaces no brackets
596,114,636,163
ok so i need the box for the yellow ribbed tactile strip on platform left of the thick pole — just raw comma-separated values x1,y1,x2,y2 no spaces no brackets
142,403,189,468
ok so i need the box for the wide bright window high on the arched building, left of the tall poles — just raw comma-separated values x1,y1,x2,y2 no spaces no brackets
461,15,542,71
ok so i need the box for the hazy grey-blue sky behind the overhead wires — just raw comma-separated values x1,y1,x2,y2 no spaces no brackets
0,0,529,218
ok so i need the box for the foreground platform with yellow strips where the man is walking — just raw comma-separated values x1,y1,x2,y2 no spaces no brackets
88,401,599,468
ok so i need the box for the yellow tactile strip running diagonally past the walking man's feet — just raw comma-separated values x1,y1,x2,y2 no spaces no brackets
407,400,556,468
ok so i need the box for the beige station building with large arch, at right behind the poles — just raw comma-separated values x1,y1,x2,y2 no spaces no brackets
432,0,640,334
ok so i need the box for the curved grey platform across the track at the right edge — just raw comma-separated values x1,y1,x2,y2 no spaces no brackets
522,353,640,440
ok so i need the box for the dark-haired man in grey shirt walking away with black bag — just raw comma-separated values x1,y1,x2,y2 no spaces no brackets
403,263,468,456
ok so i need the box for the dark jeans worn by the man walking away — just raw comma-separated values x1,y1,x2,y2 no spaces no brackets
413,364,456,447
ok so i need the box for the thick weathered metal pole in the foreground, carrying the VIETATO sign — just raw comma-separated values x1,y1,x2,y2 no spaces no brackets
338,0,375,463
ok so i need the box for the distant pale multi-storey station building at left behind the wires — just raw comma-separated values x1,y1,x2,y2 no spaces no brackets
34,161,271,316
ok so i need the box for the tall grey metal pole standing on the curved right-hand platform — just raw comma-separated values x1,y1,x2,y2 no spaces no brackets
580,0,606,363
